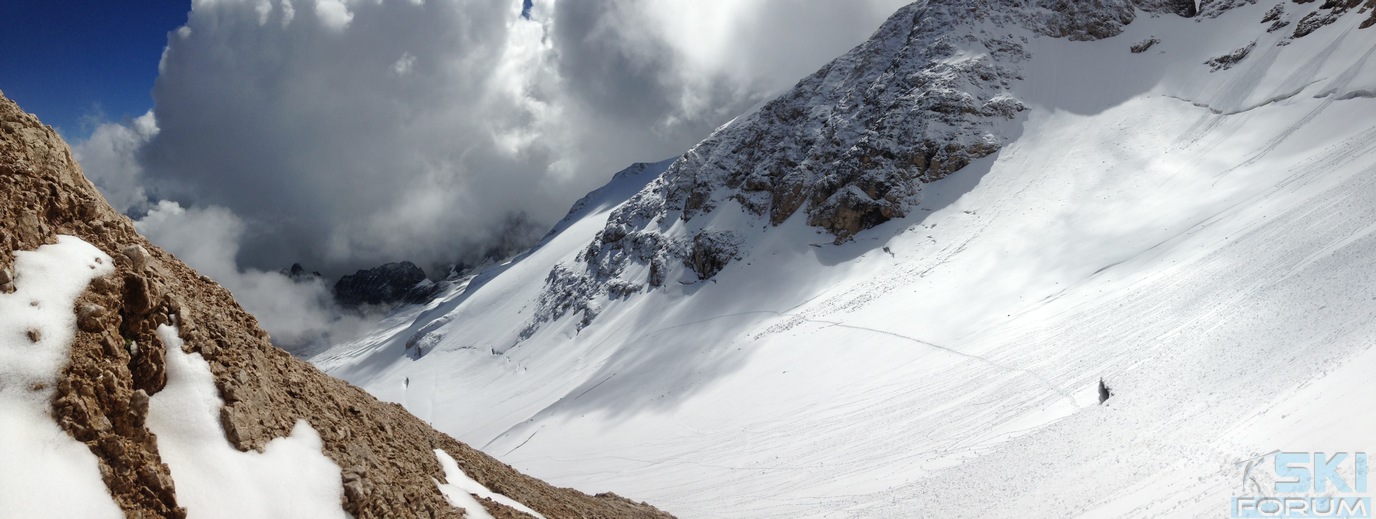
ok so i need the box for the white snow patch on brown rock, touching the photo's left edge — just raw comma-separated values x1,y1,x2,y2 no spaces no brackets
0,235,124,518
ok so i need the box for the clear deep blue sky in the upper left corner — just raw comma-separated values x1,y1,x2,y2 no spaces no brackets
0,0,191,140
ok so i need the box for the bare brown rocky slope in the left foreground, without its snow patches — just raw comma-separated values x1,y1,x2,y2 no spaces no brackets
0,96,665,518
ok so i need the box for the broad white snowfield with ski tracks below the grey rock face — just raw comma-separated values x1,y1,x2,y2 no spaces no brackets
318,3,1376,518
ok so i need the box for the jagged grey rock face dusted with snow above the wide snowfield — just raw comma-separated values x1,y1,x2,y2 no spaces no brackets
522,0,1194,337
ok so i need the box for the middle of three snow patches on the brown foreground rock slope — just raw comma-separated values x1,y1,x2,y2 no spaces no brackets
147,325,347,519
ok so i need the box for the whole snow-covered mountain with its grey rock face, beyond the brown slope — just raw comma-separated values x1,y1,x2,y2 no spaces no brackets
314,0,1376,518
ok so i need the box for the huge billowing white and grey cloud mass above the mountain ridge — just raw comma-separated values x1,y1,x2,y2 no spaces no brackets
115,0,901,274
